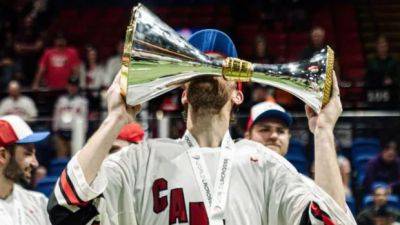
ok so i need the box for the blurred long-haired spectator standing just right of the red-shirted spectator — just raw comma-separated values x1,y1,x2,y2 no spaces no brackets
80,45,105,90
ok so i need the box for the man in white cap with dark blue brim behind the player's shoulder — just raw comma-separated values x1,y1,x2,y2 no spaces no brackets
246,102,293,156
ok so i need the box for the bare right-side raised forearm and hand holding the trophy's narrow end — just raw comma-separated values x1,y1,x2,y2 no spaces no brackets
306,74,346,209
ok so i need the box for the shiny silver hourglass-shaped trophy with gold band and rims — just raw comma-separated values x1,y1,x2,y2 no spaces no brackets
121,4,334,113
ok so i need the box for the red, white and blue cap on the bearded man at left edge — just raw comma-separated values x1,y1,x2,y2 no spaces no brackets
0,115,50,147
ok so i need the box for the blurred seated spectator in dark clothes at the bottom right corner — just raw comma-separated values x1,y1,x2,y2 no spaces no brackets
356,184,400,225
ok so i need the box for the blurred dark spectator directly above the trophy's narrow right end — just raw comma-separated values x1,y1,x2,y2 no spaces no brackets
300,27,326,59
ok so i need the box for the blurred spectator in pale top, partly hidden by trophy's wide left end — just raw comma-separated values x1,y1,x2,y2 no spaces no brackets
103,40,124,87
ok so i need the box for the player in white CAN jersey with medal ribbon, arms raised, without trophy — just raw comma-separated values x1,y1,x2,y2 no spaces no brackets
48,30,356,225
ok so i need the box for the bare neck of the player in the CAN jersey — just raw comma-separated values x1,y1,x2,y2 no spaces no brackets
187,109,230,148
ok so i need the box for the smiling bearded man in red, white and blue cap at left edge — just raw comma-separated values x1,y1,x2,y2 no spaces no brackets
0,115,50,225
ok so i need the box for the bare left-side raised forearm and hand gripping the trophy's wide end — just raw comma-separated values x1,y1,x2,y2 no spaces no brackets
77,73,140,184
